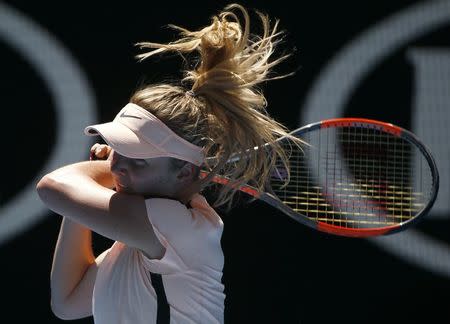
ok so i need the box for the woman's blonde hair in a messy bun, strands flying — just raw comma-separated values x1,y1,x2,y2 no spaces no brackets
130,4,300,207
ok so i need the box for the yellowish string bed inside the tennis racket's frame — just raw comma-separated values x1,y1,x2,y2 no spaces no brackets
271,127,431,228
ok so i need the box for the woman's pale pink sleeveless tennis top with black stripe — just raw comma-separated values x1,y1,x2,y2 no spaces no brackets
93,195,225,324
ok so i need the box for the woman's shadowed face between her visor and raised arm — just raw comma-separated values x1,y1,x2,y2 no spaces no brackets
111,151,179,198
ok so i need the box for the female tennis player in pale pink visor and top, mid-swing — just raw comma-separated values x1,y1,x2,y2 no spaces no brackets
37,4,298,324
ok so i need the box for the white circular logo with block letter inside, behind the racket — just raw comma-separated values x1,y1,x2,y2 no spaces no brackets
300,1,450,277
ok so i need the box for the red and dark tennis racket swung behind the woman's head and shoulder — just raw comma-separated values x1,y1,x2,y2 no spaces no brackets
200,118,439,237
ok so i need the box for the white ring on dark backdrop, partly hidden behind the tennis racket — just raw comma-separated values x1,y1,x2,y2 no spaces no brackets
300,1,450,277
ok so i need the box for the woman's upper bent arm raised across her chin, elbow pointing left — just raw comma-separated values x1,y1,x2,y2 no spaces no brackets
37,161,156,247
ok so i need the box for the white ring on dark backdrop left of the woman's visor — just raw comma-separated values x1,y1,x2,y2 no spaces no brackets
0,2,96,244
